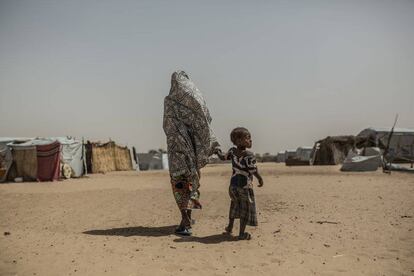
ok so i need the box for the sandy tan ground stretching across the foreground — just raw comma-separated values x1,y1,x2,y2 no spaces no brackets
0,164,414,275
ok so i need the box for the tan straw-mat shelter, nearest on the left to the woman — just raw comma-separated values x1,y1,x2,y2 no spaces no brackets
85,141,133,173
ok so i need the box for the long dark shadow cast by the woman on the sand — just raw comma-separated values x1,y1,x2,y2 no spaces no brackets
83,225,177,237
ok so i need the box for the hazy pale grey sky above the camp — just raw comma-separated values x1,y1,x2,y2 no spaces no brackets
0,0,414,153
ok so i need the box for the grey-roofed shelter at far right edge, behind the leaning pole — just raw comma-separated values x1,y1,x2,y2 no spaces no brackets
357,128,414,163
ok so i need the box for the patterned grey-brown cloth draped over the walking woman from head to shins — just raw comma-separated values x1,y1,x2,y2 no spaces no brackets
163,71,219,209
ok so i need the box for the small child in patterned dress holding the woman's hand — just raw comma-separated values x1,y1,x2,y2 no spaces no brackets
216,127,263,240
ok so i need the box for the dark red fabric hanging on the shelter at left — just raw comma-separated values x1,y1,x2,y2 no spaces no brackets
36,141,61,181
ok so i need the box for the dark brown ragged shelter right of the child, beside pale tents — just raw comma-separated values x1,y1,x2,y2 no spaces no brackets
311,135,364,165
